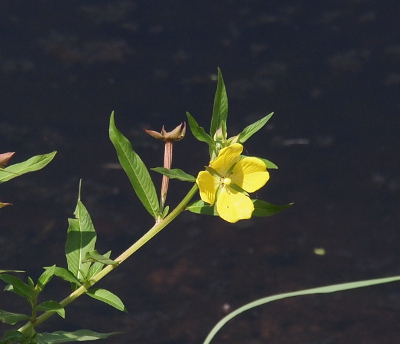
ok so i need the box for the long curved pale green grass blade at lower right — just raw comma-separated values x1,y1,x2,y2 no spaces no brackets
203,276,400,344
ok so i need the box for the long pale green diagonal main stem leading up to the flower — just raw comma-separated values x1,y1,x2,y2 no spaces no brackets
18,184,197,333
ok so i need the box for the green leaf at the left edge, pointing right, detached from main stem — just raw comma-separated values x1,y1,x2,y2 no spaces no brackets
0,152,57,184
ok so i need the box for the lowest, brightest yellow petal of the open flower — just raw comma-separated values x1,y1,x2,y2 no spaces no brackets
217,187,254,223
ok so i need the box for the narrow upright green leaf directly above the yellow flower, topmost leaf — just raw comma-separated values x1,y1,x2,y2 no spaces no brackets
210,68,228,137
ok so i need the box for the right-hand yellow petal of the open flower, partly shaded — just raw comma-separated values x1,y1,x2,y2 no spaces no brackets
230,157,269,193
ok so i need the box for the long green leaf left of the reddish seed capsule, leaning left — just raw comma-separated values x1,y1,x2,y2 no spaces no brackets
109,112,159,218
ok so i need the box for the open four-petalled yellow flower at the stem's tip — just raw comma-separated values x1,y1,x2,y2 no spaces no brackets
196,143,269,223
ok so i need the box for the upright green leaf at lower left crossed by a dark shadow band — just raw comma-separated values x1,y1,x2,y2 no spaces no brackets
65,200,96,282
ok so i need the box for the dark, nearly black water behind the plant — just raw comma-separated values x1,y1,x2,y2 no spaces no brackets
0,0,400,344
